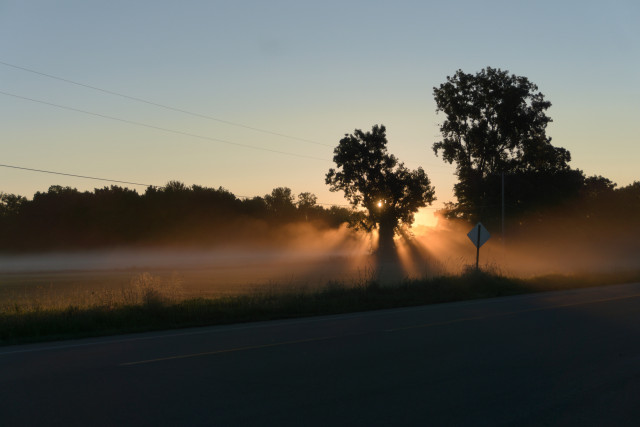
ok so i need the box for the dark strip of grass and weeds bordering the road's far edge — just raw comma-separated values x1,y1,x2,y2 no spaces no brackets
0,271,640,345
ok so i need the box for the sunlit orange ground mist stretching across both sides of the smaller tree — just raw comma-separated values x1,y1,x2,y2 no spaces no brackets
0,214,640,293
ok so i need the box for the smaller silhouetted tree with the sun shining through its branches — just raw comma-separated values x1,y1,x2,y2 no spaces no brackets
325,125,435,254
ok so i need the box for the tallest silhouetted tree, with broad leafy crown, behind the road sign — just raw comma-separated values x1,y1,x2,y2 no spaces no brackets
433,67,581,224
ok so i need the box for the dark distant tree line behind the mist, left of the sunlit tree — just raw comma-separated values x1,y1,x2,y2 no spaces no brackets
0,181,354,252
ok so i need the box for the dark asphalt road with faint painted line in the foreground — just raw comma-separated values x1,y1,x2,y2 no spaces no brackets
0,284,640,426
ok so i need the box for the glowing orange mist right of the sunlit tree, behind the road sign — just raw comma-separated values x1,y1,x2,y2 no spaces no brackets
413,217,640,277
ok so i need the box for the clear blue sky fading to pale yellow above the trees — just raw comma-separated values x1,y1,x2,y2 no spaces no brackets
0,0,640,227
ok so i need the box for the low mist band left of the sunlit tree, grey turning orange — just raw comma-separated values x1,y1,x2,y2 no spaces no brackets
0,223,374,288
